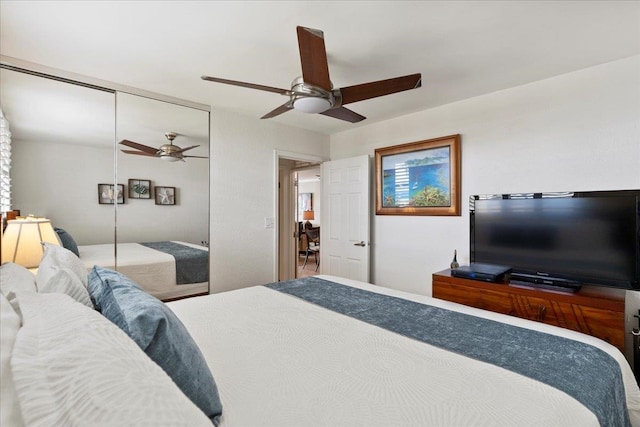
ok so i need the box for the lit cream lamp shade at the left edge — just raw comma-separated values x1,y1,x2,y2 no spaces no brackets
2,218,60,268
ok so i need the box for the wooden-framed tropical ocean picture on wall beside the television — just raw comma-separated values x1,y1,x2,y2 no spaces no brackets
375,134,461,216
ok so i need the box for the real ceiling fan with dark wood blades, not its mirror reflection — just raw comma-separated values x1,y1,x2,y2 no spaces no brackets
201,26,422,123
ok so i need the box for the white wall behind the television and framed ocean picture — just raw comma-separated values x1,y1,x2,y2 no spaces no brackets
331,56,640,295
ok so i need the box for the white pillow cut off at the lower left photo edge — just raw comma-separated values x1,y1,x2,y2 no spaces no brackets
0,294,24,427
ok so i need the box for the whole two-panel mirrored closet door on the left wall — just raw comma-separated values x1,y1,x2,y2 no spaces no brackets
0,63,209,300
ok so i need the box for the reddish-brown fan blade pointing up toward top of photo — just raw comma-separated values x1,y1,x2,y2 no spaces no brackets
296,27,331,90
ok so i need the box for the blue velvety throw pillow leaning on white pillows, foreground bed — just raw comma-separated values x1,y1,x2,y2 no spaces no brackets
89,266,222,425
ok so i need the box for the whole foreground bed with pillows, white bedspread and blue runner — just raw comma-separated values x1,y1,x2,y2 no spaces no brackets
0,247,640,427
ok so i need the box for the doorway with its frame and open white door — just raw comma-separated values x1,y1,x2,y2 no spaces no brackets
274,150,371,282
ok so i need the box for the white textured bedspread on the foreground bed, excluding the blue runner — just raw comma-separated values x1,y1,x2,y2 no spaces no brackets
168,276,640,427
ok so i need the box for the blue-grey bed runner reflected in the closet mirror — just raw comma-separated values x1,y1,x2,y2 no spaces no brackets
140,242,209,285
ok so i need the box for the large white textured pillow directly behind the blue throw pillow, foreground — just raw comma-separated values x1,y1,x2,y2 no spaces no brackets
11,293,211,427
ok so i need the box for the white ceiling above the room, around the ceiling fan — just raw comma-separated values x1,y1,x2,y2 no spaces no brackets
0,0,640,134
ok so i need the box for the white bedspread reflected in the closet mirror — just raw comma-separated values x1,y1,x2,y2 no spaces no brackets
78,242,208,299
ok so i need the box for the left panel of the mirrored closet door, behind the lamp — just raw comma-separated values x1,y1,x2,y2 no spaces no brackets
0,69,115,247
